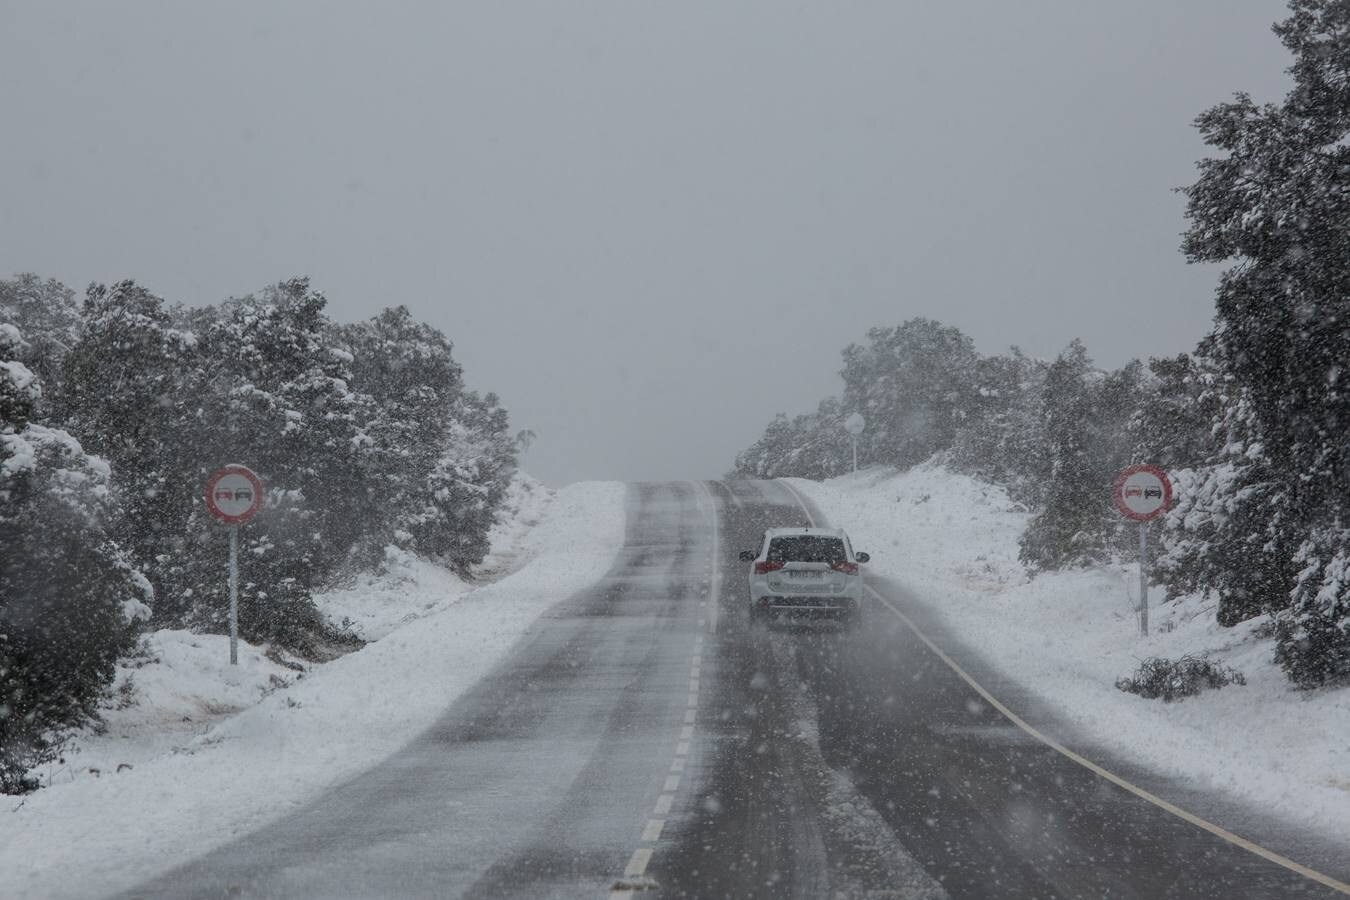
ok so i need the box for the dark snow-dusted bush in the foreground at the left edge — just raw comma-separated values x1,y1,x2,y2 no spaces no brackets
0,322,153,792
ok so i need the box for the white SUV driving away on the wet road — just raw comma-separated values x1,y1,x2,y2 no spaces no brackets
741,528,869,623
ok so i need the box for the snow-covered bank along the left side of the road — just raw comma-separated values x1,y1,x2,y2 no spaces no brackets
0,482,625,897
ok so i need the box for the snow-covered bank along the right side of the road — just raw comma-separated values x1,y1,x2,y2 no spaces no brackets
788,464,1350,834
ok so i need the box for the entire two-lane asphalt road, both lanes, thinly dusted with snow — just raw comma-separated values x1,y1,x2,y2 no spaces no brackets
124,482,1346,899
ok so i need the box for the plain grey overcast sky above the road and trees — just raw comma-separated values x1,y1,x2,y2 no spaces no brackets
0,0,1287,483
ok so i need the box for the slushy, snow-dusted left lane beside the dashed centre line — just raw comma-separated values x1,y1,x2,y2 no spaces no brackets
116,484,714,897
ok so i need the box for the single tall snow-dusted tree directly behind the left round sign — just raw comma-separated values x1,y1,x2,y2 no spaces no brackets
165,279,374,652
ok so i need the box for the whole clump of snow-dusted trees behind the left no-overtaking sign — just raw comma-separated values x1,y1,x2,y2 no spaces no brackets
9,277,517,652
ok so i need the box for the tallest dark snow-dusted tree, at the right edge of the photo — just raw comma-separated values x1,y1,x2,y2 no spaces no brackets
1183,0,1350,684
